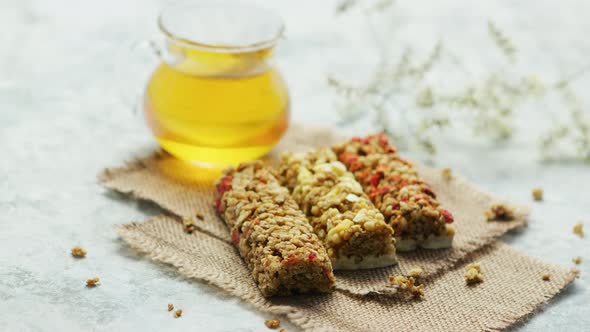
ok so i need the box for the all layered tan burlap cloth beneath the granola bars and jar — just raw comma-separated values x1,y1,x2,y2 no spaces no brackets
99,126,576,331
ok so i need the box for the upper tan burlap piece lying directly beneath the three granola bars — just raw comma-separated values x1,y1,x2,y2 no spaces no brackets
99,126,528,295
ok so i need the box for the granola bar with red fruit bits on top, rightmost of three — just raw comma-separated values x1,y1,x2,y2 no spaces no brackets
333,134,455,251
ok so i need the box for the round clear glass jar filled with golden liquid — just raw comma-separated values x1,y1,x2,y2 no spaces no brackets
143,2,289,168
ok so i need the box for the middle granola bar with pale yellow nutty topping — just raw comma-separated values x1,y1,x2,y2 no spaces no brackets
279,149,397,270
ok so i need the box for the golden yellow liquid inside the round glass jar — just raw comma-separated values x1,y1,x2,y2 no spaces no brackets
144,44,289,167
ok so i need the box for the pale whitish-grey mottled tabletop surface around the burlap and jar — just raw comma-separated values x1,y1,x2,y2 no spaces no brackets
0,0,590,331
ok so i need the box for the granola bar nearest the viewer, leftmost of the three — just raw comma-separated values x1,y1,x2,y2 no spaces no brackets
215,161,334,297
